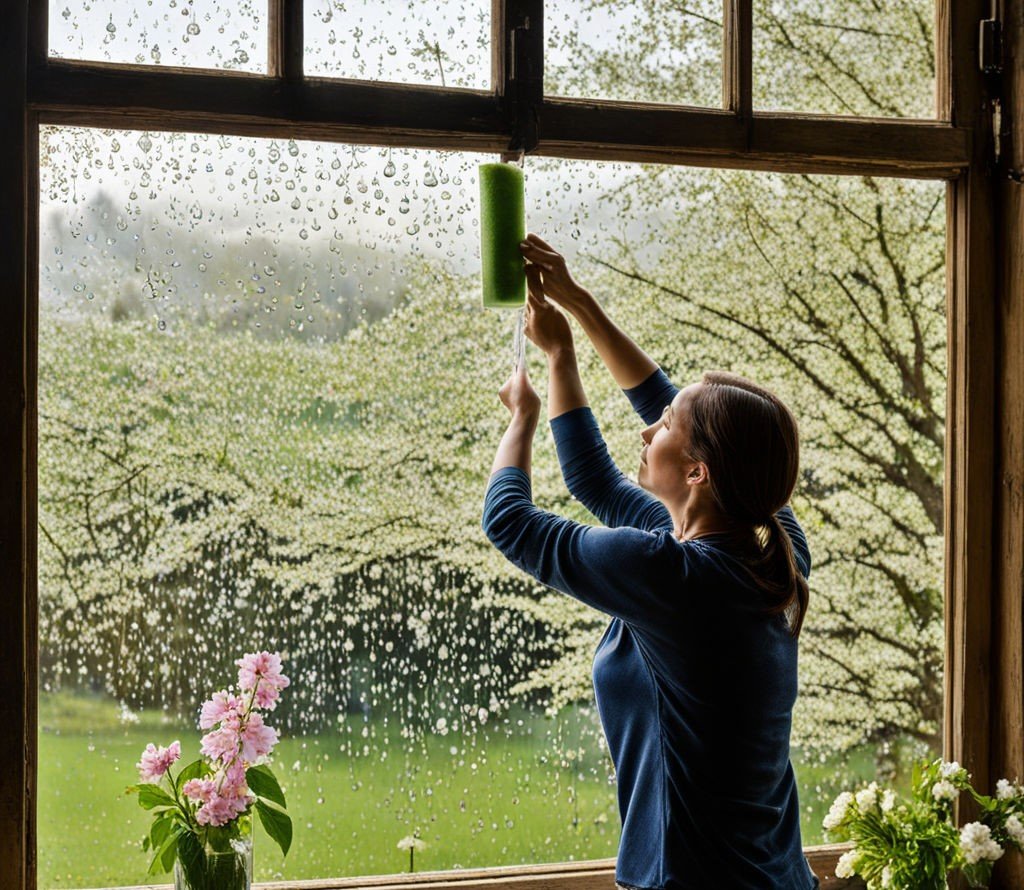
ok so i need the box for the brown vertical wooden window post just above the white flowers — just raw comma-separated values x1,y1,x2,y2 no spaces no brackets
939,17,996,888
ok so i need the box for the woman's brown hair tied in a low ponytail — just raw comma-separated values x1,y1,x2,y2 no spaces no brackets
689,371,809,637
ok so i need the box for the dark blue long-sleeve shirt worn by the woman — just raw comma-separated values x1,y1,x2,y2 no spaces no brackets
483,370,818,890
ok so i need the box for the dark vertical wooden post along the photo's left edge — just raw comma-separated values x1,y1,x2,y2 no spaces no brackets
0,3,38,888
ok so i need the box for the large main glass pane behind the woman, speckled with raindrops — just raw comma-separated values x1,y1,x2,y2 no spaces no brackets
38,128,946,888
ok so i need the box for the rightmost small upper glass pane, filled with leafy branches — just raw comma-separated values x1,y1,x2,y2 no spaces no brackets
754,0,935,118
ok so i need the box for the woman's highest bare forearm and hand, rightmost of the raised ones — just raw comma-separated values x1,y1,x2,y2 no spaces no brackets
520,234,657,389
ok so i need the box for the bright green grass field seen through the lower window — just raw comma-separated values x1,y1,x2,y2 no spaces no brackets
38,694,921,890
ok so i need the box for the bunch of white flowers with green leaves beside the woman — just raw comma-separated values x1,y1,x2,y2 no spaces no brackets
823,760,1024,890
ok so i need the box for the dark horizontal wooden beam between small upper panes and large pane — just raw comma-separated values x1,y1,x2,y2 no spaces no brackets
30,60,970,178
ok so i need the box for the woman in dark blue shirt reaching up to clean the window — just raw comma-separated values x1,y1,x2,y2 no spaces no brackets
483,235,818,890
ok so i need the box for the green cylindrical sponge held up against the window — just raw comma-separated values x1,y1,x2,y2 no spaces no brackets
480,164,526,309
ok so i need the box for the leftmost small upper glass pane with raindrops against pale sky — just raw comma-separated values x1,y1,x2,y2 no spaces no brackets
49,0,267,73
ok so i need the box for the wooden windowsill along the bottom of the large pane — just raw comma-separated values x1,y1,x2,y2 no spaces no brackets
74,844,864,890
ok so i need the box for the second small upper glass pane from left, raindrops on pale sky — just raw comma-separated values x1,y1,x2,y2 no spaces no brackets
303,0,490,90
